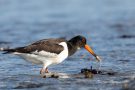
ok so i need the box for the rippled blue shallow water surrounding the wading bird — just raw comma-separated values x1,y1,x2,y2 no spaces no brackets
0,0,135,90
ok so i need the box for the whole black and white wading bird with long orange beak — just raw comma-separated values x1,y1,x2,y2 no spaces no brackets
2,35,100,74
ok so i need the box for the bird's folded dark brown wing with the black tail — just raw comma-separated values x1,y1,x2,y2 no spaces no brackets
4,39,65,54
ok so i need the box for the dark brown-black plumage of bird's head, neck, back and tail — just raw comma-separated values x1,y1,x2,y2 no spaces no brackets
4,35,86,56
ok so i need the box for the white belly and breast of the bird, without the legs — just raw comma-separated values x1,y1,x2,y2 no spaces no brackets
14,42,68,65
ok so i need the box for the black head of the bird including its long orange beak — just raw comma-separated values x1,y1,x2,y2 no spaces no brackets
71,35,101,61
